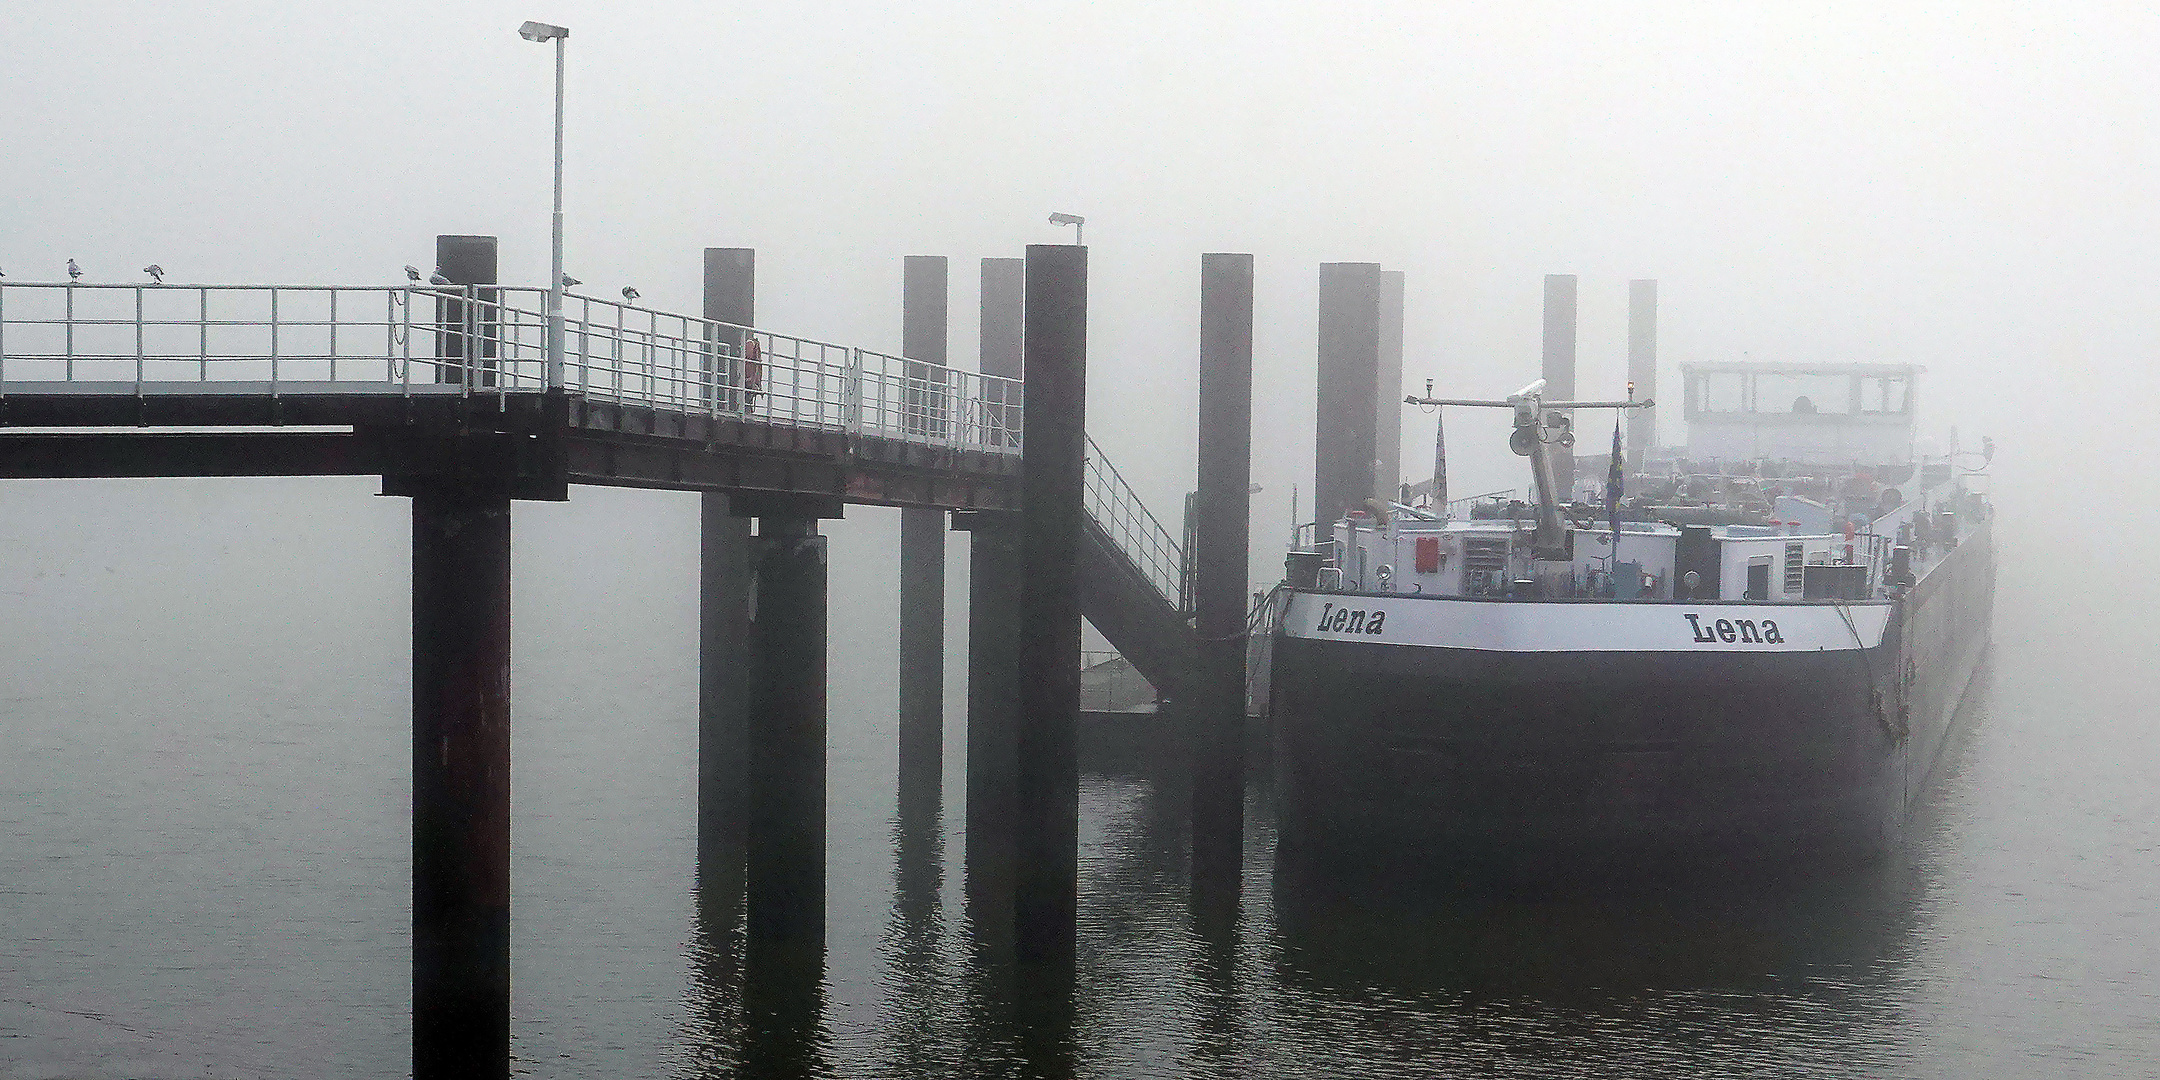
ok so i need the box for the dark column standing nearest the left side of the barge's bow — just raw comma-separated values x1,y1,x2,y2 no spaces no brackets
1192,255,1253,922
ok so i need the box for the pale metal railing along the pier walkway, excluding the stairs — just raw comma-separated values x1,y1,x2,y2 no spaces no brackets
0,283,1024,454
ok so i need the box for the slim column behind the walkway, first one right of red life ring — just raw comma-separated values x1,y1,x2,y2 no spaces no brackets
899,255,950,791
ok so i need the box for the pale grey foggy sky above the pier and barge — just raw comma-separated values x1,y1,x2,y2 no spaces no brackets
0,0,2160,572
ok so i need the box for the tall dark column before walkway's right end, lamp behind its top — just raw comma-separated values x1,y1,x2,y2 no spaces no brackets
1013,244,1080,970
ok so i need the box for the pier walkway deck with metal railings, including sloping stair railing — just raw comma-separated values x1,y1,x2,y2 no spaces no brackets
0,281,1190,687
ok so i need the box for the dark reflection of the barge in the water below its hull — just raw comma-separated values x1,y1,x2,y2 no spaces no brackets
1246,670,1989,1076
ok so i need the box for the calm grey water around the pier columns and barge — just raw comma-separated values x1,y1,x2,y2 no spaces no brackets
0,482,2160,1078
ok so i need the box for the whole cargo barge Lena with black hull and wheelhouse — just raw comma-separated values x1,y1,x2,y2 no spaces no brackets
1255,363,1994,870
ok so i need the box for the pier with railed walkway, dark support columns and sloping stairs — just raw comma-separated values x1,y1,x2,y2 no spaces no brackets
0,235,1251,1078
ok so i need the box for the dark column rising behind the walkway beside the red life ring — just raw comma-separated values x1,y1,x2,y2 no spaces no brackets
698,248,758,898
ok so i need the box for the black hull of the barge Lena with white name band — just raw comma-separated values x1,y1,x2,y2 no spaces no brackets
1268,527,1994,873
